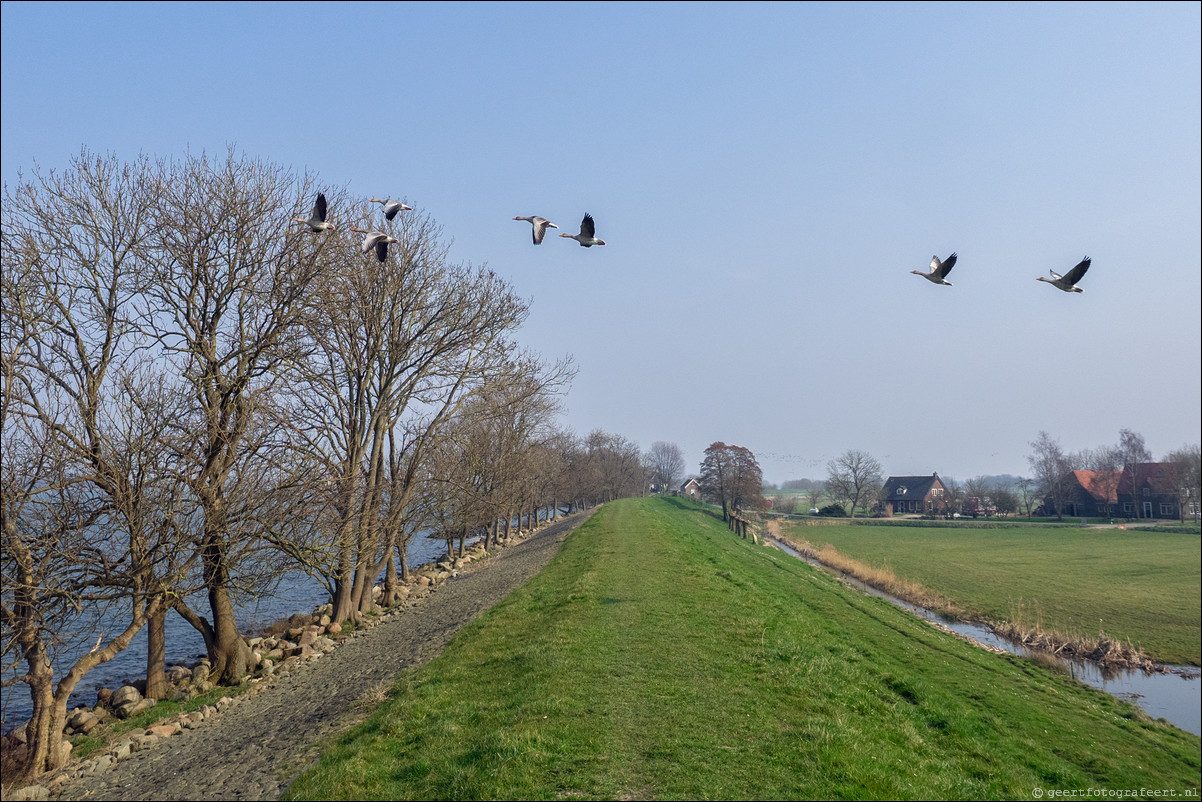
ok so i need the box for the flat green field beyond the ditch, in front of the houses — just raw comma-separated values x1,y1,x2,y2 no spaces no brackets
783,523,1202,666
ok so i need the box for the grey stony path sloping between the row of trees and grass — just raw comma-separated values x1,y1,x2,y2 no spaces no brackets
59,513,588,800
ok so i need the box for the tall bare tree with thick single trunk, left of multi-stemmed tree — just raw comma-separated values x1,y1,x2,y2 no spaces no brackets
135,149,339,683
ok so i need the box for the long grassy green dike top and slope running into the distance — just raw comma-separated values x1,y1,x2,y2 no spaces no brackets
285,499,1202,800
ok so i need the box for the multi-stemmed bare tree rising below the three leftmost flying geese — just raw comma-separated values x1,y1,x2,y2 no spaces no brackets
286,199,545,619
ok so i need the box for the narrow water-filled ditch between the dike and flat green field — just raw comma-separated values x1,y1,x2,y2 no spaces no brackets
768,537,1202,735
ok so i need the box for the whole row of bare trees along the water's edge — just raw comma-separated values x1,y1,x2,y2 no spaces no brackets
0,149,644,779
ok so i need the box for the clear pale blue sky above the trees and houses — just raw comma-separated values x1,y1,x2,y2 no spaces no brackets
0,2,1202,482
